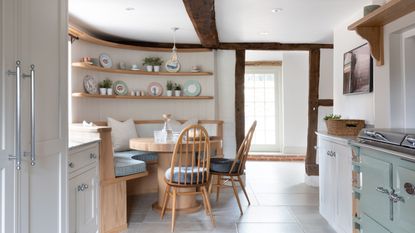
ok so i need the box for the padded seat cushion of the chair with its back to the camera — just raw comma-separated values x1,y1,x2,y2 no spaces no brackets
165,167,208,184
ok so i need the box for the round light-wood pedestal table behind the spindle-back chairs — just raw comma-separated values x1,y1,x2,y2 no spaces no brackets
130,138,222,212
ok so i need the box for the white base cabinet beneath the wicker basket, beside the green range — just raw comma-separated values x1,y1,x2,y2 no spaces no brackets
317,134,353,233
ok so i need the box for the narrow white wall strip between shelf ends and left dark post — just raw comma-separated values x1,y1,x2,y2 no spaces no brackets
215,50,236,158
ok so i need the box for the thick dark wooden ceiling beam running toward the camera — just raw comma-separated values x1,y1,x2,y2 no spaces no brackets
183,0,219,48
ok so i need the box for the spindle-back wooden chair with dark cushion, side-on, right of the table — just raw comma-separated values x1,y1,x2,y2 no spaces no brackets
209,121,257,215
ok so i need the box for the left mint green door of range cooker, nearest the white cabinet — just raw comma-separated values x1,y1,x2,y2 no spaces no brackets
360,155,393,228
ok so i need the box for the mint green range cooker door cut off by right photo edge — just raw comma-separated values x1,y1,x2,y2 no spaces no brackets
394,161,415,232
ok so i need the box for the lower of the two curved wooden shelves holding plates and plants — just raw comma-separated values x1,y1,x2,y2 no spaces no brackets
72,92,213,100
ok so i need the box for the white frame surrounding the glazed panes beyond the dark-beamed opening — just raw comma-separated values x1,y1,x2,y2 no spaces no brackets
245,66,283,152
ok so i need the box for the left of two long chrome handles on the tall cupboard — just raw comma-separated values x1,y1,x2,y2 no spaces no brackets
7,60,22,170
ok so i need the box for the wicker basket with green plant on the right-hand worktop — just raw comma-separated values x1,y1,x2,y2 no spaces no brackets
323,114,365,136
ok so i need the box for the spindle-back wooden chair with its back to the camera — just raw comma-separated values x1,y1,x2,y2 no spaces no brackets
160,125,215,232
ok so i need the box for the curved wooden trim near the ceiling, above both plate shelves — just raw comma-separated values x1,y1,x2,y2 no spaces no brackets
68,25,212,53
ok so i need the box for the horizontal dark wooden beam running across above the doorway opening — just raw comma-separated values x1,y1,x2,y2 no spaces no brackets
218,43,333,51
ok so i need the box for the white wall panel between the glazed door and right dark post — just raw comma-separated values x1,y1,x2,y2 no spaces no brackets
282,52,309,154
